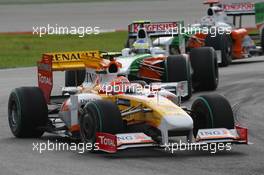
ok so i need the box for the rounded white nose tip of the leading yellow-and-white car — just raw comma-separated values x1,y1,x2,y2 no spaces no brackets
160,114,193,131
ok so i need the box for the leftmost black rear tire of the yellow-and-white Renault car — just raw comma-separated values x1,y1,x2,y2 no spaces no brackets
8,87,48,138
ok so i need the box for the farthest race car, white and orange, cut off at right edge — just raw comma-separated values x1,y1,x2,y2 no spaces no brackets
187,0,264,66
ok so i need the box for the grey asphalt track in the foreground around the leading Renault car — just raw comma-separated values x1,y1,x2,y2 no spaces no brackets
0,1,264,175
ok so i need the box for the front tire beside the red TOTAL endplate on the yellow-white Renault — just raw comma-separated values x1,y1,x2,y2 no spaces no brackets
79,100,123,152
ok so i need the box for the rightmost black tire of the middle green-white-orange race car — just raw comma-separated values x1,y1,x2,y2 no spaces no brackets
190,47,219,91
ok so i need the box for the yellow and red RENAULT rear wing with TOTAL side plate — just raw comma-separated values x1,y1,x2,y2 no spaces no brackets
37,51,119,103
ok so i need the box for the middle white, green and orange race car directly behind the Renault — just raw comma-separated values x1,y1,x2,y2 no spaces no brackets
66,21,219,100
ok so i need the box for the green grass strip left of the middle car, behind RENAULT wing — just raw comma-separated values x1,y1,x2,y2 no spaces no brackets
0,32,127,68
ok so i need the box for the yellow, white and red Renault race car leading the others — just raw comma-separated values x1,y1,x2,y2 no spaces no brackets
8,51,247,153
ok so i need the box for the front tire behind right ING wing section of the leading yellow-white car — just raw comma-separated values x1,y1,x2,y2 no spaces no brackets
191,94,234,137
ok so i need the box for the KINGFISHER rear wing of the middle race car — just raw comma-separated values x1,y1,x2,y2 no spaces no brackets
128,21,184,37
